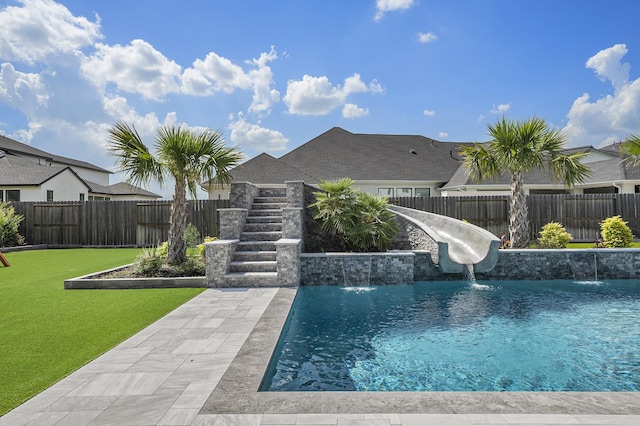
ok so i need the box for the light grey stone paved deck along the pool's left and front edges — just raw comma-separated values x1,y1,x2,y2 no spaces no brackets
0,288,640,426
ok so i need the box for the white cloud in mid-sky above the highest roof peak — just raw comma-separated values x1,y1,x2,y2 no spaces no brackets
283,74,382,115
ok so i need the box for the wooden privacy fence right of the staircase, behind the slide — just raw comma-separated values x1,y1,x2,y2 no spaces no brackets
391,194,640,241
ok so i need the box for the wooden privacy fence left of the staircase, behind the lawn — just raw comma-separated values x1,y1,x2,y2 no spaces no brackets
12,200,229,247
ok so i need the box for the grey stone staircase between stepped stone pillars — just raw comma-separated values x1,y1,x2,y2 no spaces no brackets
225,188,287,285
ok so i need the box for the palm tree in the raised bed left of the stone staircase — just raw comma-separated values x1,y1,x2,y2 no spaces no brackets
108,121,242,263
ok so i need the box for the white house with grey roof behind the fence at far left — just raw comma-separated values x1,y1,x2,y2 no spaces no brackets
0,136,161,201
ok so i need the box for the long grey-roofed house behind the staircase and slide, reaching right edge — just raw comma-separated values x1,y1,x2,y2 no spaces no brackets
203,127,640,199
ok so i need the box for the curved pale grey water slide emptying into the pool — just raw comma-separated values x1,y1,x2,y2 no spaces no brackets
389,206,500,273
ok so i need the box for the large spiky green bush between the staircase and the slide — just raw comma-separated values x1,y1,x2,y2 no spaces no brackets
309,178,399,252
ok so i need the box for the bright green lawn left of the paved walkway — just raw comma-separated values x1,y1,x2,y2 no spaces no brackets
0,249,203,415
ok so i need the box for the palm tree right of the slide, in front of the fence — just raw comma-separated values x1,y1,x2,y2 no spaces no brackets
461,117,590,248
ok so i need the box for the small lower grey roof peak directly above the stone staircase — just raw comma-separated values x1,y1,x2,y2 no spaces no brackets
231,153,319,184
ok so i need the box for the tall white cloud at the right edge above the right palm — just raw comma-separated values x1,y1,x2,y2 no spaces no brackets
563,44,640,146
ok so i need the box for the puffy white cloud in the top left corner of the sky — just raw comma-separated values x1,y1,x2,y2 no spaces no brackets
0,0,102,65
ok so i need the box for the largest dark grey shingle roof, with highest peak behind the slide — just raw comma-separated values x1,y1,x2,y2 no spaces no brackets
279,127,468,182
